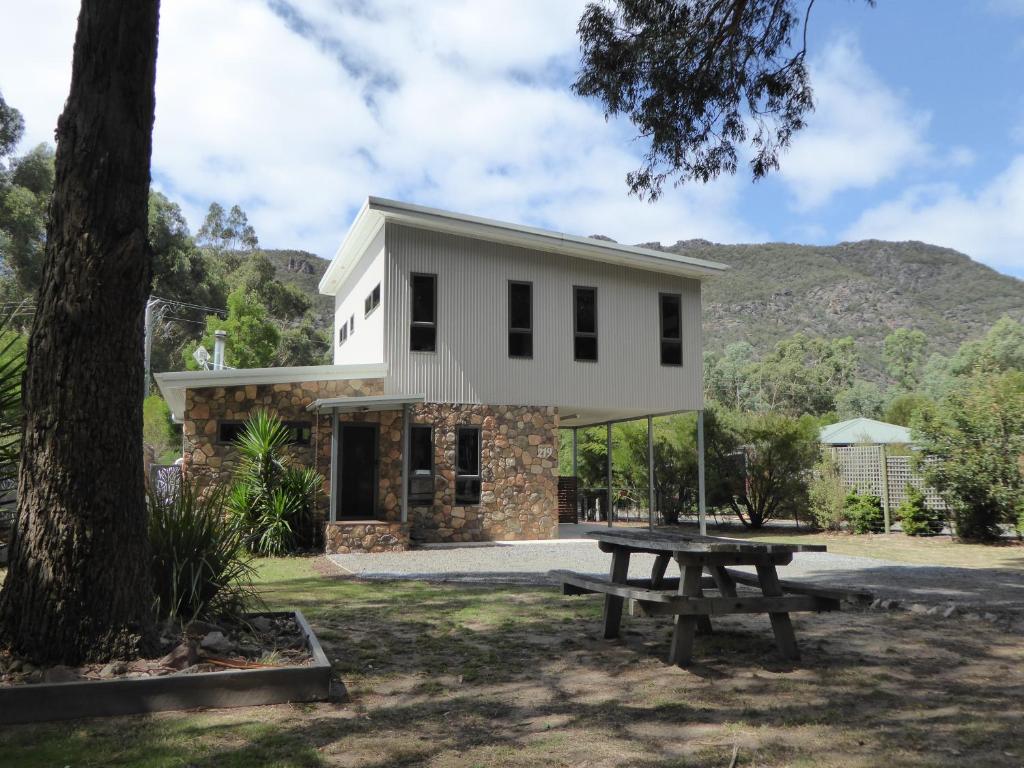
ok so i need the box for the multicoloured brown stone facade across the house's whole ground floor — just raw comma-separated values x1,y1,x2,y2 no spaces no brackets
182,379,558,552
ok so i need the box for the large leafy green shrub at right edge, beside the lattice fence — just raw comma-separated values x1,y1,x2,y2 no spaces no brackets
912,368,1024,541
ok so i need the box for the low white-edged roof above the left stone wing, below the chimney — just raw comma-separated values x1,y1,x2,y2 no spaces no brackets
154,364,387,422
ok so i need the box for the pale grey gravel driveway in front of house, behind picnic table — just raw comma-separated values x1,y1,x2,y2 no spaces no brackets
331,541,1024,612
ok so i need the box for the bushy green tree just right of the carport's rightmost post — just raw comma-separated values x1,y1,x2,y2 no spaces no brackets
708,413,818,528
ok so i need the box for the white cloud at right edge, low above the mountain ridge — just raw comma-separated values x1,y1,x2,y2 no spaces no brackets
846,155,1024,275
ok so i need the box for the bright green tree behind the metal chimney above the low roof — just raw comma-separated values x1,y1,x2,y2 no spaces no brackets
184,291,281,371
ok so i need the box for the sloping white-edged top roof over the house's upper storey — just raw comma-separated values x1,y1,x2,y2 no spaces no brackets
319,197,729,296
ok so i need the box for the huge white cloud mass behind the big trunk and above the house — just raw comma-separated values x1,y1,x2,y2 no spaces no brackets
0,0,760,256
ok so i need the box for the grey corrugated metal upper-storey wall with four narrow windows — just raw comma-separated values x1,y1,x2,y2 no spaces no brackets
384,223,702,414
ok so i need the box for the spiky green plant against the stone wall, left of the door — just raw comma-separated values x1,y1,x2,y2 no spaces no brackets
228,412,324,556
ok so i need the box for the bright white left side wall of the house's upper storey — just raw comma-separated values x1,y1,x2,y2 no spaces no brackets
334,227,386,366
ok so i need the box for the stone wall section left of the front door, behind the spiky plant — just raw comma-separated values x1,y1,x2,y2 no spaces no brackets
181,379,384,516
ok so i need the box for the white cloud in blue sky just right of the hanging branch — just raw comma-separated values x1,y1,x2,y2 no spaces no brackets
780,39,933,211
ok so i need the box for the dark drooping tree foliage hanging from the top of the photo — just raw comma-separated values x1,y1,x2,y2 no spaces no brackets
572,0,873,200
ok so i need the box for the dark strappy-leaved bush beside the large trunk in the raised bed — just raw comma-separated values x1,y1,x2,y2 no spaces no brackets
147,478,258,622
